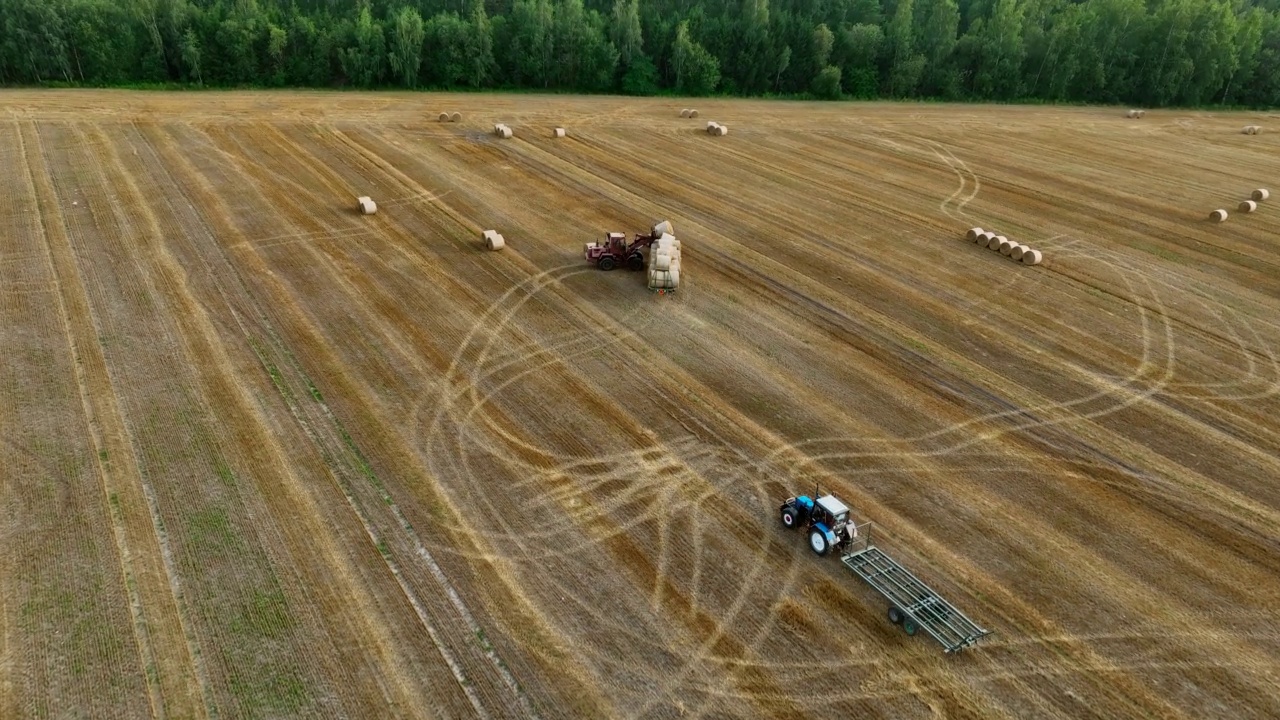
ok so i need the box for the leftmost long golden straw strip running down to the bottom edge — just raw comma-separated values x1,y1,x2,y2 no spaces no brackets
19,123,212,716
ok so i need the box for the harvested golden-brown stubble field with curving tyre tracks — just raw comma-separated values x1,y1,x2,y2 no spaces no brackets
0,91,1280,720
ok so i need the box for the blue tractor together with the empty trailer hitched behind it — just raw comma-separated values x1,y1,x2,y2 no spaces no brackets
780,493,991,655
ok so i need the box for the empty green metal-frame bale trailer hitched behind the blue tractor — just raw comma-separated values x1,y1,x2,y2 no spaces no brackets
840,523,992,653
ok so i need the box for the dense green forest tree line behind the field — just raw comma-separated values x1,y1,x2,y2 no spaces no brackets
0,0,1280,106
